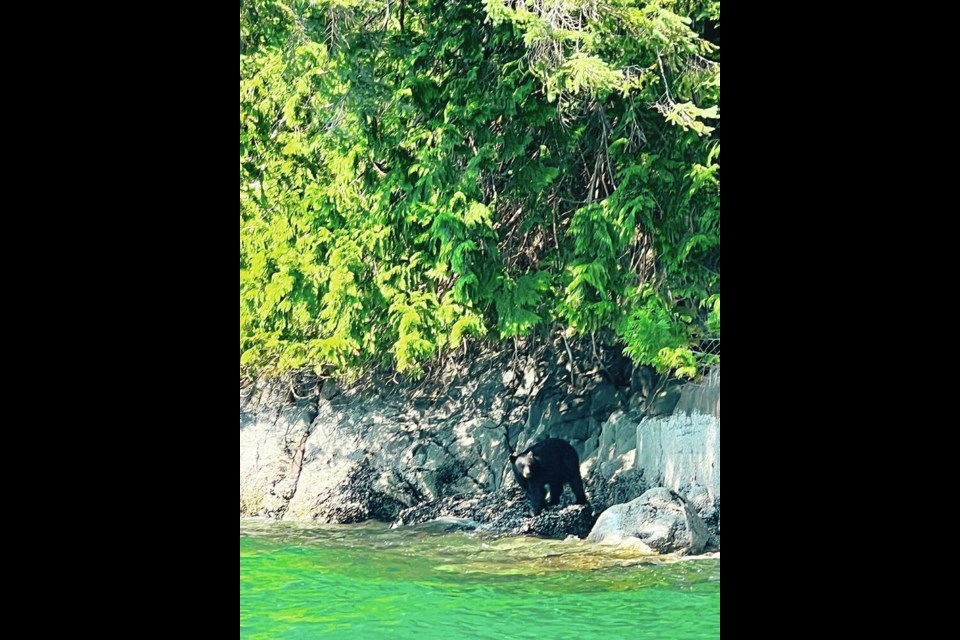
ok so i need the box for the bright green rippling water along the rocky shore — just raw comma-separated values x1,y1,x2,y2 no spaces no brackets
240,523,720,640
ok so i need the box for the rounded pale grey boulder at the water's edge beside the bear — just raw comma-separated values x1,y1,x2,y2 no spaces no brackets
587,488,711,554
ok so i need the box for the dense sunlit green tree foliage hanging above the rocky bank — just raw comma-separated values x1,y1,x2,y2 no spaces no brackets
240,0,720,377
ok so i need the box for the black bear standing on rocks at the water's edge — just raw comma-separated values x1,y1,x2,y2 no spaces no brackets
510,438,587,516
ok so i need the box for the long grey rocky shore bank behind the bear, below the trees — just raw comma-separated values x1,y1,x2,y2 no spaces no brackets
240,346,720,537
